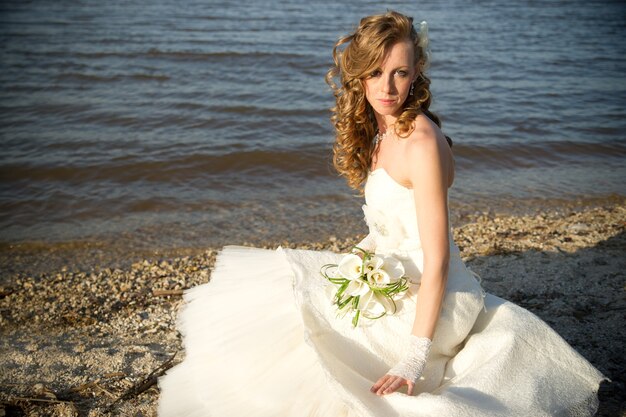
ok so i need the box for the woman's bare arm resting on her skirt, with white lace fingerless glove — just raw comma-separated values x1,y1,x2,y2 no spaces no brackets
372,122,453,395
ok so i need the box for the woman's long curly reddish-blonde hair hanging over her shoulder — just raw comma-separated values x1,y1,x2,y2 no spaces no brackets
326,11,449,189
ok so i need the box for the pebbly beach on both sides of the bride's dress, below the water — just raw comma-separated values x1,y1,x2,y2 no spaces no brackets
0,201,626,416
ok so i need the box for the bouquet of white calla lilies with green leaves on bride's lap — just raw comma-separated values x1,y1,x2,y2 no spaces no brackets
320,247,409,327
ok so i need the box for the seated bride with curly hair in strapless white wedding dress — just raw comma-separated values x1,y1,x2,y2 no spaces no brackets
159,11,603,417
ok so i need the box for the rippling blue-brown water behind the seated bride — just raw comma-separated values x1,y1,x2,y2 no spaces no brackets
0,0,626,247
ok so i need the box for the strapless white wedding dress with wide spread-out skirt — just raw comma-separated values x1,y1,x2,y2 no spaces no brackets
159,169,604,417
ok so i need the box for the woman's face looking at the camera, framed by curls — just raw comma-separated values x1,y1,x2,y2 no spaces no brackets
365,40,416,122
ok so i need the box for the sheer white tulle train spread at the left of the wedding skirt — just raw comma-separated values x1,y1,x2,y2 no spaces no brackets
158,246,354,417
